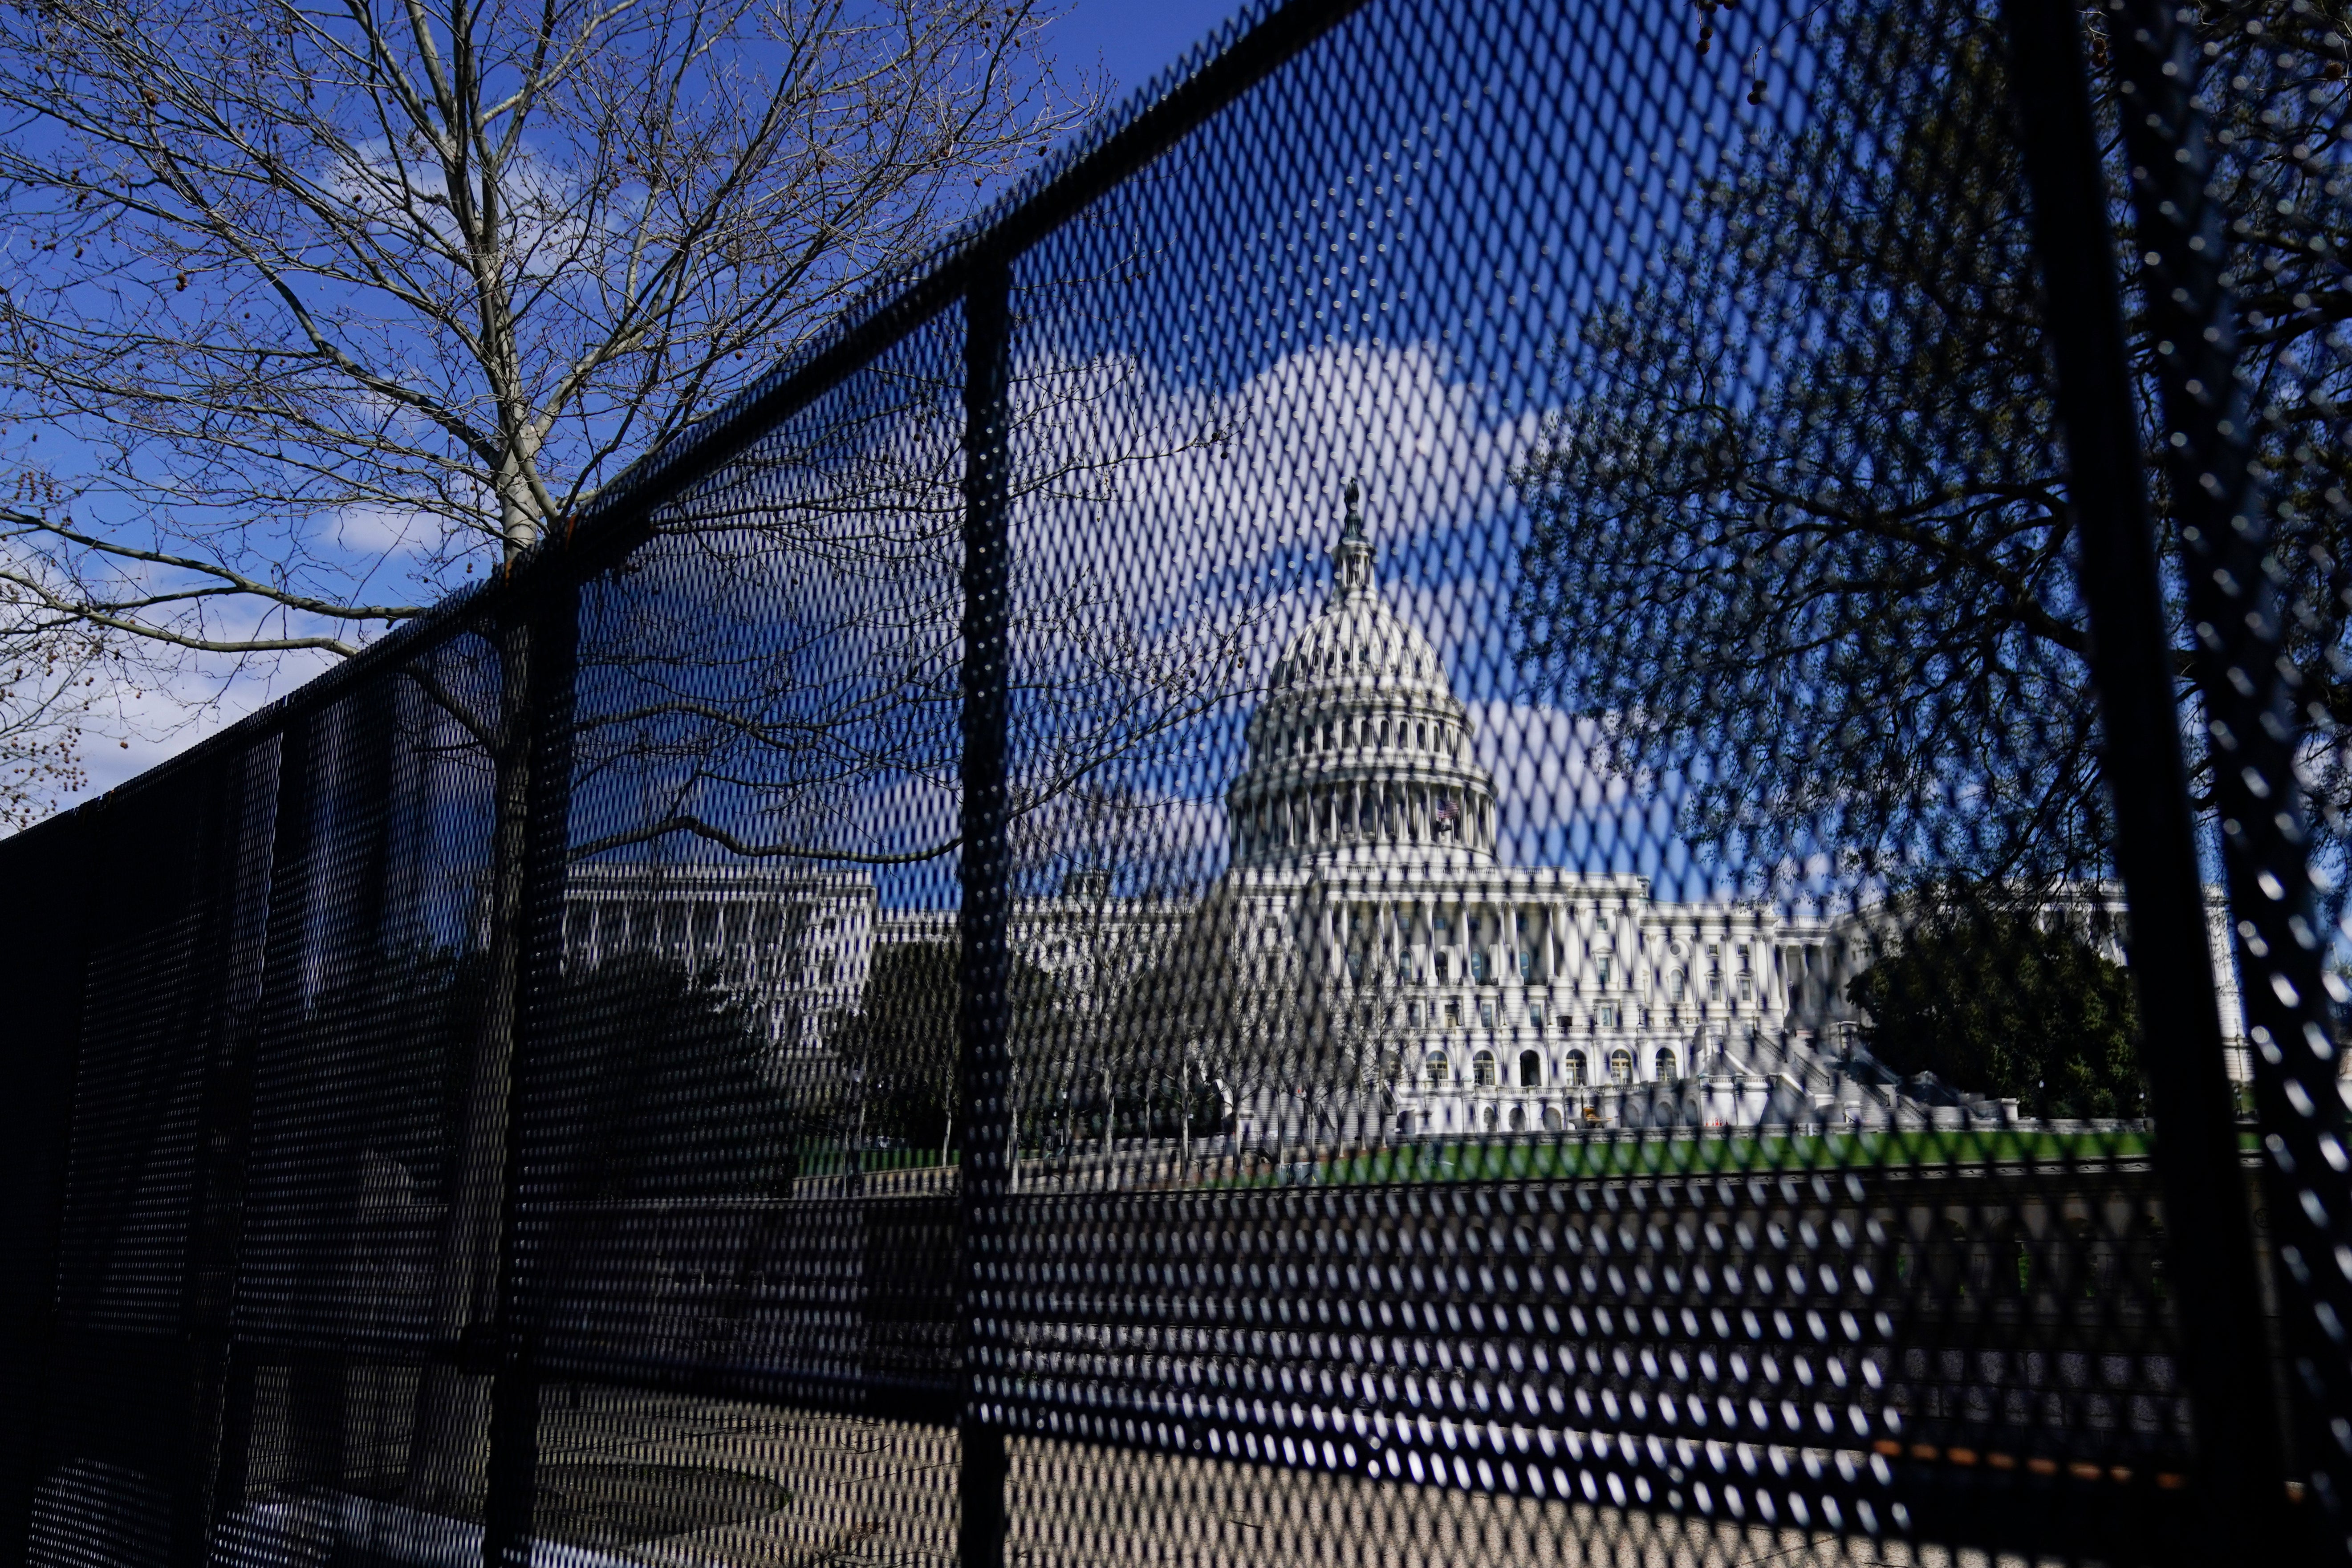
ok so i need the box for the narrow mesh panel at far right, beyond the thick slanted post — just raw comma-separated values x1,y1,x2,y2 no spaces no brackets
2091,5,2352,1554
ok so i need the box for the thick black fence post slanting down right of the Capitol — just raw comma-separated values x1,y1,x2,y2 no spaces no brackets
2004,0,2298,1561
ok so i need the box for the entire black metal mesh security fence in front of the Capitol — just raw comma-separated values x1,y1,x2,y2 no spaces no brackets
0,0,2352,1566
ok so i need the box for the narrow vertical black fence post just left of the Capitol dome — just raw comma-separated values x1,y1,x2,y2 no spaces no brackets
955,256,1019,1568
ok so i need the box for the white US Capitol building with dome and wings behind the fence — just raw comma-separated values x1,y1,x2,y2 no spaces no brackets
565,496,2246,1142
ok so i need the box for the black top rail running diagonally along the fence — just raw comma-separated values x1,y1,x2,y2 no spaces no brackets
9,0,1364,839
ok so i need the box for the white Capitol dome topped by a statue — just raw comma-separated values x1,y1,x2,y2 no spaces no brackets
1225,484,1494,867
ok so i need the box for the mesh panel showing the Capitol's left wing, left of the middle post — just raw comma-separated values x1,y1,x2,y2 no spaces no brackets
520,310,962,1418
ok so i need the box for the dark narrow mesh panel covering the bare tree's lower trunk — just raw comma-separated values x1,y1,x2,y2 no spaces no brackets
238,677,487,1354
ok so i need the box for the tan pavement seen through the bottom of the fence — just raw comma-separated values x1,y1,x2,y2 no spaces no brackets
371,1392,2079,1568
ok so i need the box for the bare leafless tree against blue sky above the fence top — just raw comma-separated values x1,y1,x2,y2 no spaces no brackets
0,0,1080,691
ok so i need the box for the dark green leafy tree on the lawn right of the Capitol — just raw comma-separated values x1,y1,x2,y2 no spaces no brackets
1846,910,2145,1117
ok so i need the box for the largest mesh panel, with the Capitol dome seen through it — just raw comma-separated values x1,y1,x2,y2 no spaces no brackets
976,5,2190,1544
